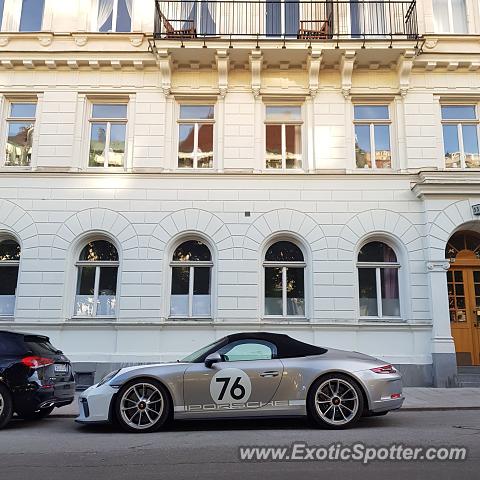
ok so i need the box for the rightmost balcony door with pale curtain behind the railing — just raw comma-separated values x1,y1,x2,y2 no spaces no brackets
349,0,388,38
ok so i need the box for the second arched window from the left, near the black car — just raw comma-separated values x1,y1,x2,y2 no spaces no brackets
75,240,119,317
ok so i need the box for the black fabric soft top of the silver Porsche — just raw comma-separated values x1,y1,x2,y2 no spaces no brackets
218,332,327,358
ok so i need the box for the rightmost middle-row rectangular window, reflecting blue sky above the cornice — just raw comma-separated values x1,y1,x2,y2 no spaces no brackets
442,105,480,168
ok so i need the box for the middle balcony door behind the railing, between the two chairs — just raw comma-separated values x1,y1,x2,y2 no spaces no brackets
265,0,300,37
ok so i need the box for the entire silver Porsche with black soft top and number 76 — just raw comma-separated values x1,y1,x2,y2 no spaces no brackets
76,332,404,432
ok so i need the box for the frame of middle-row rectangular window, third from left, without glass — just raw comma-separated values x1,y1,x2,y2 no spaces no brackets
175,100,217,172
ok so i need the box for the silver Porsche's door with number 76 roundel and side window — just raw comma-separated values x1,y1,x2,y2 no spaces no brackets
184,339,283,413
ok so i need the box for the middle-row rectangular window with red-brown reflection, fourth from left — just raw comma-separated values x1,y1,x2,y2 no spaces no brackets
265,105,302,170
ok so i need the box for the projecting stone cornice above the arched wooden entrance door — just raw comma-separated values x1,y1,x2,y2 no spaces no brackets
411,170,480,198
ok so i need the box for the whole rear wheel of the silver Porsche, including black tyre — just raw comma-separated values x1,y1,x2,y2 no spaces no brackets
307,373,364,430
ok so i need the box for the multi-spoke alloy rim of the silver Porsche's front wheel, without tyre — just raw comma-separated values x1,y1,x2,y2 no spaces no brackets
120,382,165,430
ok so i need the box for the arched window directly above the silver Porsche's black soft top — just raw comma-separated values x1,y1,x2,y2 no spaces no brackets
263,241,305,317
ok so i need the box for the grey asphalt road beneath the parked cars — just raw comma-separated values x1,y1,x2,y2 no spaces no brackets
0,410,480,480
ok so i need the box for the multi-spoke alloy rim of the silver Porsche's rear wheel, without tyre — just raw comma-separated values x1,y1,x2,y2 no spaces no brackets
315,378,359,425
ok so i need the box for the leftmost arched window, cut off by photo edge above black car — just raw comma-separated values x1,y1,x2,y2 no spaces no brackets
0,239,20,316
